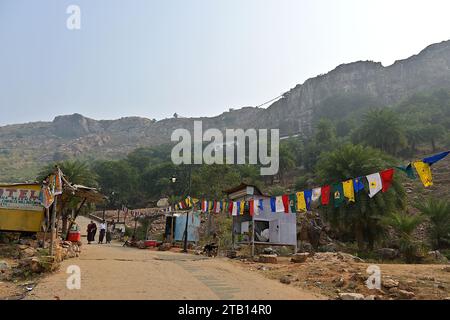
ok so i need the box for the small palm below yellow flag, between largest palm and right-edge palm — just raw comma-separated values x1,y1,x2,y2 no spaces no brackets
382,212,424,263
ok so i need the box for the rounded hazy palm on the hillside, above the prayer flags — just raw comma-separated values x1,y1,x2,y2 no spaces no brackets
354,109,406,155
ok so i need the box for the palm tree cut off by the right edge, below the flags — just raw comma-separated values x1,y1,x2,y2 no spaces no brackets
415,199,450,249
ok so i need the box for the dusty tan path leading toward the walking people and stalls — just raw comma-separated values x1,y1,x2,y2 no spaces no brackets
26,218,323,300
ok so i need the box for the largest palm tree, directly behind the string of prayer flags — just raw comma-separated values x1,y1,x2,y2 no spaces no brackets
316,144,406,251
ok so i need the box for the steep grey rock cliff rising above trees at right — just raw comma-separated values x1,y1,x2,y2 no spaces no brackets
258,41,450,132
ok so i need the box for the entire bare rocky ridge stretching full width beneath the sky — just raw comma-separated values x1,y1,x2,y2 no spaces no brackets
0,41,450,181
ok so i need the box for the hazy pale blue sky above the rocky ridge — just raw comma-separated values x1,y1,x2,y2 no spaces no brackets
0,0,450,125
